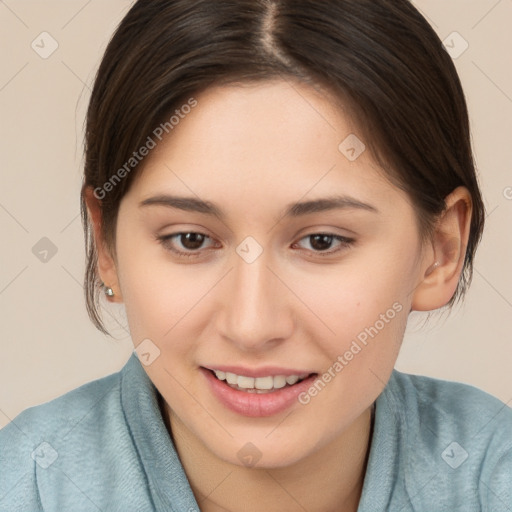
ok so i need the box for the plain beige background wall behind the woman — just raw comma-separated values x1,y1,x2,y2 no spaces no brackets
0,0,512,426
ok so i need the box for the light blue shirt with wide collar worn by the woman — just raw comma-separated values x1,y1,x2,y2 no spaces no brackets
0,355,512,512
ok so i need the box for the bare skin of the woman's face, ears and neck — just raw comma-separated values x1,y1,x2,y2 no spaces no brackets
87,81,471,511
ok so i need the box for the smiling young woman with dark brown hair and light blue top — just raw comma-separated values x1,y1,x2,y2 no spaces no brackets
0,0,512,512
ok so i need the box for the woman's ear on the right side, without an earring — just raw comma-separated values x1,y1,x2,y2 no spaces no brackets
411,187,473,311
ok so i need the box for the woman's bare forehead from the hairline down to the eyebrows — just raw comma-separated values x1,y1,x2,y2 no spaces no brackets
127,80,408,216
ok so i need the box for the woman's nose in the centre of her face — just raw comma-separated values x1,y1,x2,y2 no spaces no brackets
220,252,293,351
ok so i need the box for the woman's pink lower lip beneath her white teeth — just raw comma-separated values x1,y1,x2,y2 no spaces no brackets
201,368,316,418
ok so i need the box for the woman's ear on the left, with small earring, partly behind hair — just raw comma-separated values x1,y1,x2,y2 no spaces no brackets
84,187,123,302
